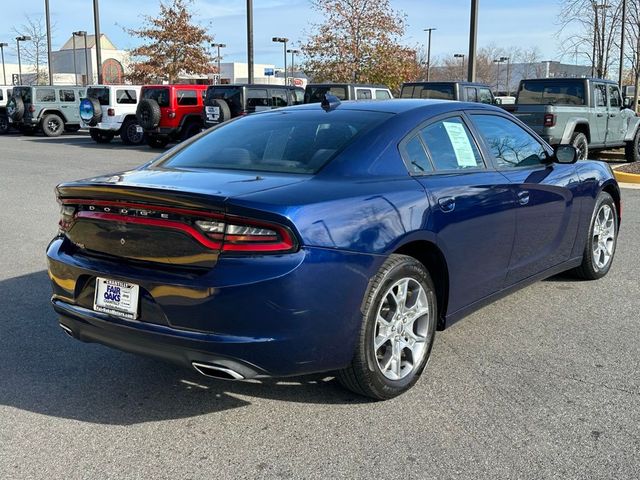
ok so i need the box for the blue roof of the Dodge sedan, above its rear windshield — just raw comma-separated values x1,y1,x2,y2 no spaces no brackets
287,98,504,114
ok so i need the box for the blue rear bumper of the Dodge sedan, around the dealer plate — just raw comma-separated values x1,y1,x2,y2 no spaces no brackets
47,238,384,378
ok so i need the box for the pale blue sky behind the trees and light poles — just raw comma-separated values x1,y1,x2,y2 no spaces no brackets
0,0,580,65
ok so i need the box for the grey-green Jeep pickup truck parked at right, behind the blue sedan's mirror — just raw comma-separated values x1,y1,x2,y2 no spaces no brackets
512,78,640,162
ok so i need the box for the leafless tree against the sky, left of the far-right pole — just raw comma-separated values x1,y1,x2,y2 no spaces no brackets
559,0,634,78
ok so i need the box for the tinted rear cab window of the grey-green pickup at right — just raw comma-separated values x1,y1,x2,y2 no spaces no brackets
516,80,585,105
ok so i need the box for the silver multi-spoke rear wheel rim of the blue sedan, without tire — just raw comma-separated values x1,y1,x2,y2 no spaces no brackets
373,278,431,380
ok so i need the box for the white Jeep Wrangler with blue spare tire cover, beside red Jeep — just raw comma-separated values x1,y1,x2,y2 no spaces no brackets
80,85,145,145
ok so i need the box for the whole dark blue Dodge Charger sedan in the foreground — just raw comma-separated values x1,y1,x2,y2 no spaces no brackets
47,97,621,399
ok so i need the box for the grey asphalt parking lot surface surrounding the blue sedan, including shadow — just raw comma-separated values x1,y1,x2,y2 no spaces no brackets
0,131,640,479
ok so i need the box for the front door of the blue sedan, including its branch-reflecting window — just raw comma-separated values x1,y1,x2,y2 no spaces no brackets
471,112,580,285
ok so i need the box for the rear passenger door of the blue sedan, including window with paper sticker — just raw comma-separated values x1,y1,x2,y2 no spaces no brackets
400,114,517,313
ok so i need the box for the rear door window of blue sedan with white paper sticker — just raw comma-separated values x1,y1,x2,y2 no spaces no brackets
420,117,484,171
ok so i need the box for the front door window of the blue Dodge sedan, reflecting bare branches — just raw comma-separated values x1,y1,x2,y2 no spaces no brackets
472,114,547,168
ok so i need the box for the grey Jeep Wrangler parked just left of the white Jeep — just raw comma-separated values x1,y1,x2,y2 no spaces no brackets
7,85,86,137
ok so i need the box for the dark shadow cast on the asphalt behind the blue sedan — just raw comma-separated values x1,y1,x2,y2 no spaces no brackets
0,271,368,425
